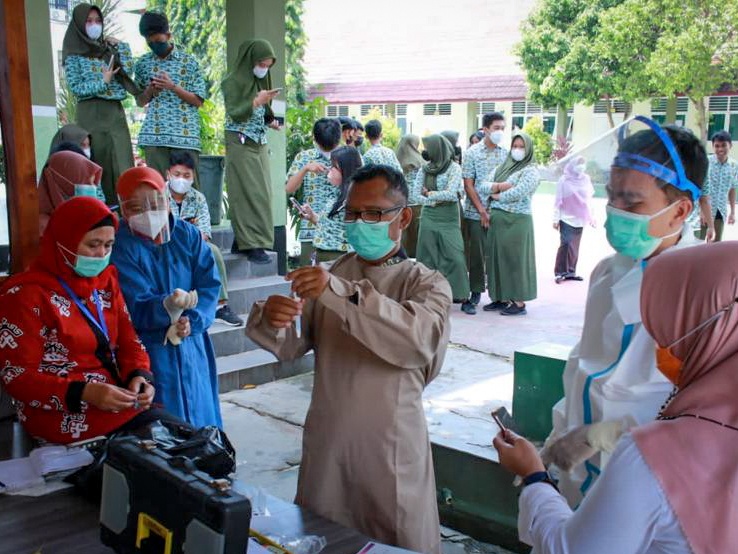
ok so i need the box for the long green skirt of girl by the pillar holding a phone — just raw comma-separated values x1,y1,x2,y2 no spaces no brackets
226,131,274,250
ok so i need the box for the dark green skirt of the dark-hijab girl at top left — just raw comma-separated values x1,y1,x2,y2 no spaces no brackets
77,98,133,206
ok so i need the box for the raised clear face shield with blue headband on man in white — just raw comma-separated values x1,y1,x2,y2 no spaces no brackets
543,116,700,210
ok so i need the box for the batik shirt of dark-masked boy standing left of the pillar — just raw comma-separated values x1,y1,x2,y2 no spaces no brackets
136,47,208,150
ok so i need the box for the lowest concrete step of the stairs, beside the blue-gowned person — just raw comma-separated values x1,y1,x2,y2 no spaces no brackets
216,348,315,394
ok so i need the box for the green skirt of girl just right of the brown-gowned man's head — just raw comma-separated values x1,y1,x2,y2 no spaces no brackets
416,202,469,300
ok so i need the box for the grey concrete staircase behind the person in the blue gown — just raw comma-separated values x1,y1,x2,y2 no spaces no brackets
209,221,313,393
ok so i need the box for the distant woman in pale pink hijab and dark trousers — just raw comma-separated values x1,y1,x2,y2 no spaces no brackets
554,156,595,283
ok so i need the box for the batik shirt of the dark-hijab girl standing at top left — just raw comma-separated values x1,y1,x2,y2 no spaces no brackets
64,42,133,100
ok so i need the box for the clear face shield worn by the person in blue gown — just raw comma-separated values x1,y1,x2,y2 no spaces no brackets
118,185,171,244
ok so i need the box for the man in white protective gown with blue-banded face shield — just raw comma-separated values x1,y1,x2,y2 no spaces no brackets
542,116,707,507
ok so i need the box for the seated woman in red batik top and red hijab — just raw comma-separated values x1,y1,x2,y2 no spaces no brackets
0,197,154,444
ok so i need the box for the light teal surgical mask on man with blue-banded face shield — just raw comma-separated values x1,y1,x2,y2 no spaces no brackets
605,201,682,260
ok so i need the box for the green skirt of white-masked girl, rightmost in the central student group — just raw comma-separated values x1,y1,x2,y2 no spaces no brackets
486,209,538,302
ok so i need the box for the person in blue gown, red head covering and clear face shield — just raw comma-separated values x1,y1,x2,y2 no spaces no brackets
111,167,222,427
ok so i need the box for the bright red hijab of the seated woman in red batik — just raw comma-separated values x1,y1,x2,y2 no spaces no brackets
2,196,118,299
